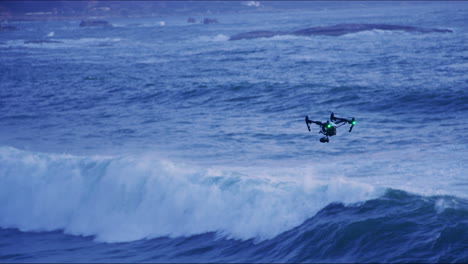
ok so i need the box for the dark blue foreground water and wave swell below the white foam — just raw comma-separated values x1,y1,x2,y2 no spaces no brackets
0,190,468,263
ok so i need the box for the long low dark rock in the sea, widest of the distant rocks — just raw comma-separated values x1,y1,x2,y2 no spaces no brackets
229,24,452,40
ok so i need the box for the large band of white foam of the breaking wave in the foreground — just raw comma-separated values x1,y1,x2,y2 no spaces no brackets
0,147,381,242
